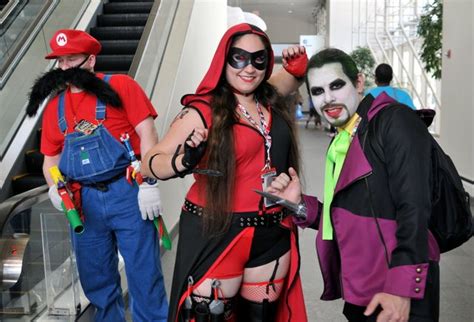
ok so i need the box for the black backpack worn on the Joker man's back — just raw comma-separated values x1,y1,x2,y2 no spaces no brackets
364,103,474,253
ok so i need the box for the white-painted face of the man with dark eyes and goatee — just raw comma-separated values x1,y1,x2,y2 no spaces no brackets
308,63,359,127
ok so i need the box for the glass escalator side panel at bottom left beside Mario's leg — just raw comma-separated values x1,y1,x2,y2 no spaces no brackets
0,194,82,321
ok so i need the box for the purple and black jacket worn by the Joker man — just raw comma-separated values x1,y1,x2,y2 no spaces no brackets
297,94,439,306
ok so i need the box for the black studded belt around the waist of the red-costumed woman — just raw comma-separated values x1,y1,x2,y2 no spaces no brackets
183,200,289,228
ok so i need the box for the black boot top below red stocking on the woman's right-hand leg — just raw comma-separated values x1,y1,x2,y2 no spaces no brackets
236,297,278,322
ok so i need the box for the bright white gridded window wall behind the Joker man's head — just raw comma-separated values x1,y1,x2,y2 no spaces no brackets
358,0,441,134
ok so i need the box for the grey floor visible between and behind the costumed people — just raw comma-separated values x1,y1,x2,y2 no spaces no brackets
157,123,474,322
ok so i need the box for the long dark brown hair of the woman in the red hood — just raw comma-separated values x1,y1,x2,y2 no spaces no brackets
203,62,300,236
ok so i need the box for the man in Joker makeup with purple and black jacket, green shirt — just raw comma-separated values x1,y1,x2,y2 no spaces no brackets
268,49,439,321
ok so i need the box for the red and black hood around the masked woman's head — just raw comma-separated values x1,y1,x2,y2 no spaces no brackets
181,23,274,106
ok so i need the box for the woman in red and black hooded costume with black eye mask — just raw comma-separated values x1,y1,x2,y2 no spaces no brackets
143,24,307,322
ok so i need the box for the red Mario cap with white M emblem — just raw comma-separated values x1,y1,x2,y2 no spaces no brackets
44,29,102,59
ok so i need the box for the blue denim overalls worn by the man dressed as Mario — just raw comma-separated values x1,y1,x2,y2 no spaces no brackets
58,75,168,322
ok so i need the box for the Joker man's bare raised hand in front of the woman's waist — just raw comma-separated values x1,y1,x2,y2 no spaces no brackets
266,167,301,203
